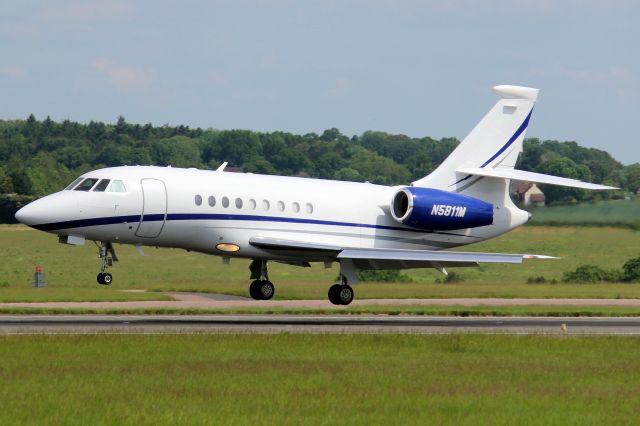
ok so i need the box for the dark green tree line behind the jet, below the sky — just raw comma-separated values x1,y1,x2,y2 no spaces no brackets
0,115,640,203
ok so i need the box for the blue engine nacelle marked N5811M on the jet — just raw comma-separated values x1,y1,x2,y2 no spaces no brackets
391,187,493,231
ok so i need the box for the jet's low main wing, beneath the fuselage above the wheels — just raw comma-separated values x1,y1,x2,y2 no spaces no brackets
250,237,555,269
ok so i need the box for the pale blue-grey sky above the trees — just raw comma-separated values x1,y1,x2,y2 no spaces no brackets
0,0,640,164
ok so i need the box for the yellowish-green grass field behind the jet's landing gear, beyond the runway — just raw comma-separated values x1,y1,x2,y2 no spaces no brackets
0,225,640,301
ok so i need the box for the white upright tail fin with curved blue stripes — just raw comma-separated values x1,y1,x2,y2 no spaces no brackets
413,86,538,192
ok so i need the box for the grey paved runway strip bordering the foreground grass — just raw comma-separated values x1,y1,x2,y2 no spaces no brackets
0,315,640,335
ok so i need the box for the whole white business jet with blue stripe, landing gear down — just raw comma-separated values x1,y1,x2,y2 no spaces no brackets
16,86,614,305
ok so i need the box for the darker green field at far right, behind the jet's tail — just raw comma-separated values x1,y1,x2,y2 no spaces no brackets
531,198,640,225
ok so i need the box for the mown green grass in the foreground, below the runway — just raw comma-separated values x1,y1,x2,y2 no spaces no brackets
0,334,640,425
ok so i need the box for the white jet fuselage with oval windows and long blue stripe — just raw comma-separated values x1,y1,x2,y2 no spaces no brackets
19,166,528,261
